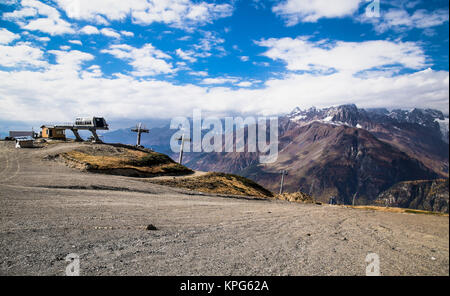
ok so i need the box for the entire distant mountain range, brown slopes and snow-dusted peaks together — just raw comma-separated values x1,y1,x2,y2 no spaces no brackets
104,105,449,204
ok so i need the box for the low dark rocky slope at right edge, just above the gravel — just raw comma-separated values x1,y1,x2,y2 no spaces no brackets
376,179,449,213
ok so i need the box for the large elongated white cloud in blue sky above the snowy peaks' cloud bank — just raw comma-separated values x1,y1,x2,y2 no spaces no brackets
257,38,427,74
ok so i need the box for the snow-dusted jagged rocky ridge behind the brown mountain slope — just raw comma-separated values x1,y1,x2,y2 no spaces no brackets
287,105,449,176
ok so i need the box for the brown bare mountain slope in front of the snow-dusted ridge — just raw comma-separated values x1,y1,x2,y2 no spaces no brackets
187,122,438,204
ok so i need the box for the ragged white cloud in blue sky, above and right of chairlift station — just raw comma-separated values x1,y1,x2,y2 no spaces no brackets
102,44,175,76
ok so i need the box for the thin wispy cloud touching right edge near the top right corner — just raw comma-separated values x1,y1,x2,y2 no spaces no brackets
359,8,449,33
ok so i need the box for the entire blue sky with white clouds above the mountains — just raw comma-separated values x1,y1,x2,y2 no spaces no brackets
0,0,449,126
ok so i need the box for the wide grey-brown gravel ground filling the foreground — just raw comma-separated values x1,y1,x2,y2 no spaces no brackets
0,141,449,275
